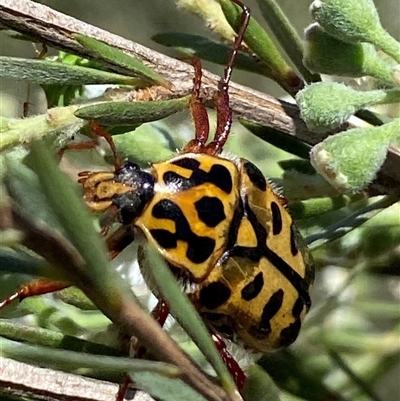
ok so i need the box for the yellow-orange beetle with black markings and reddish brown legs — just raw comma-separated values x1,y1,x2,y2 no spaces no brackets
0,0,314,392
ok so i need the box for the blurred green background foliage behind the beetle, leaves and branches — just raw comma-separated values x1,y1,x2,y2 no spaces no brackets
0,0,400,401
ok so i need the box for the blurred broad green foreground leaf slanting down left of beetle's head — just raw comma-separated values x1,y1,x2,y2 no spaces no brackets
27,142,136,309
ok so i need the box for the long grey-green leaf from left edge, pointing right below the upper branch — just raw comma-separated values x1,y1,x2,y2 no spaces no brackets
0,57,138,85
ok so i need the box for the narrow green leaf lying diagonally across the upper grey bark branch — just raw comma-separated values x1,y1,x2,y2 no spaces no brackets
73,34,171,88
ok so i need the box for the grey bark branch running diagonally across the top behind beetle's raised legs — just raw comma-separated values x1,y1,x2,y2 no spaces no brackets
0,0,400,196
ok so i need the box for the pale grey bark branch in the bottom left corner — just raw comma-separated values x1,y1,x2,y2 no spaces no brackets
0,357,154,401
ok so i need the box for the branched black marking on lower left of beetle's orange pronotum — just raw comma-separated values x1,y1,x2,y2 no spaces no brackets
150,199,215,263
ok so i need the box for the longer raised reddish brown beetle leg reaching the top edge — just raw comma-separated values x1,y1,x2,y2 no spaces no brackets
206,0,250,155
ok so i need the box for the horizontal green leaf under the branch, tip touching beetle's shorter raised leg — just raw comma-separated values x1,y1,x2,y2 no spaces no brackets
75,96,190,125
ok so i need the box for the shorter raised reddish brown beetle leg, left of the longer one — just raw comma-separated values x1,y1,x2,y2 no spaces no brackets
184,58,210,152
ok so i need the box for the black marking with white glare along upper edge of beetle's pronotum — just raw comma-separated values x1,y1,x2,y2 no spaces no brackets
163,157,233,194
